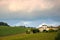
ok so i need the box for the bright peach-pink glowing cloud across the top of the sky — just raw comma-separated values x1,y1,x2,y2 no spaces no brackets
0,0,59,12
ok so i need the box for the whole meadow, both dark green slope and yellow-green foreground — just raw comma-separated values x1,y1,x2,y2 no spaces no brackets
0,26,57,40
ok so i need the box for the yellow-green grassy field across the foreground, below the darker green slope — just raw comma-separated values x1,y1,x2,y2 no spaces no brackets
0,32,57,40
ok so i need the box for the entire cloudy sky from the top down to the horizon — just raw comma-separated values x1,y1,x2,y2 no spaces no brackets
0,0,60,27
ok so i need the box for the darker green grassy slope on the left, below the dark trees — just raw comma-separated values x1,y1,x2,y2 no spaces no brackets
0,26,26,36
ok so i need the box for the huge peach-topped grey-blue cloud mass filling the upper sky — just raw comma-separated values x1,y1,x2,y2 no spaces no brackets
0,0,60,24
